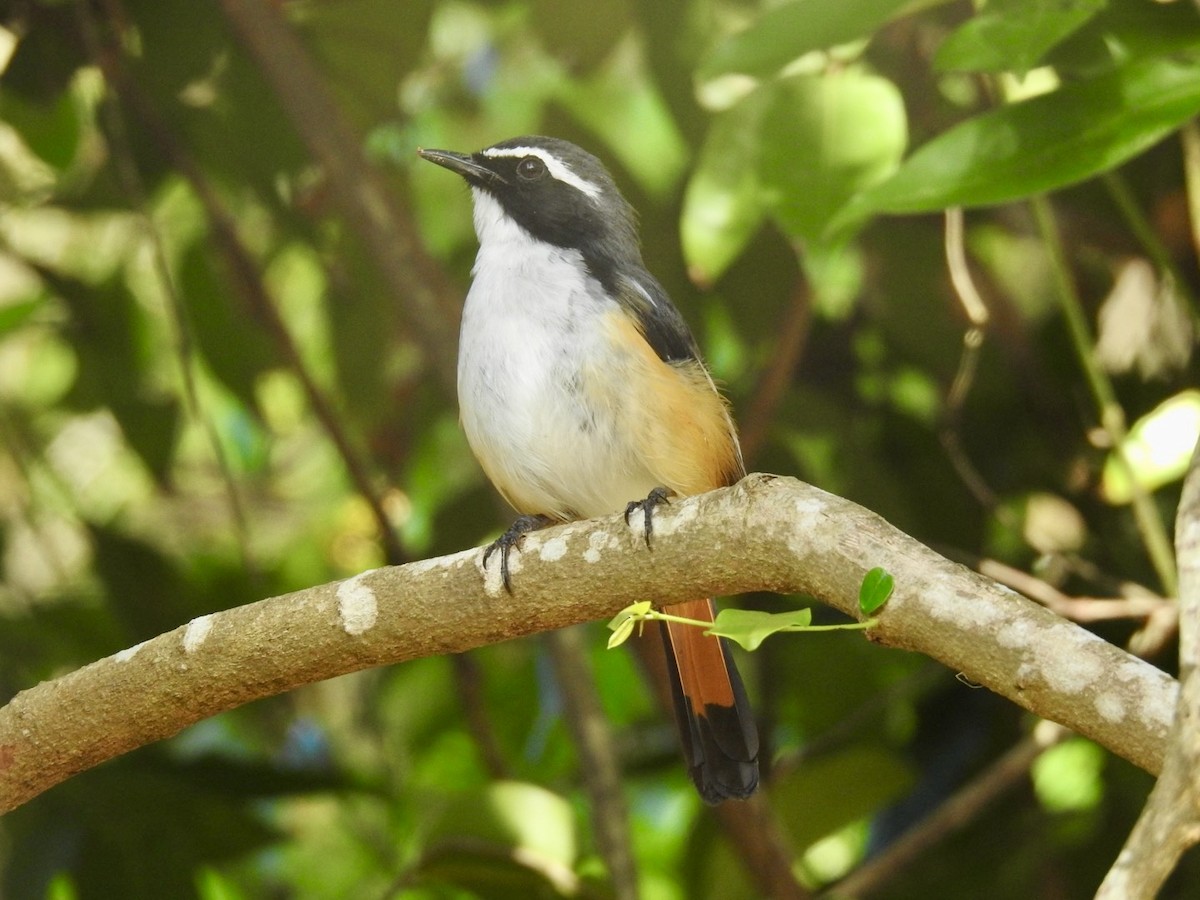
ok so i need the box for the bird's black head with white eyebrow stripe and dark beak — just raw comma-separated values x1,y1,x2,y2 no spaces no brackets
418,134,641,262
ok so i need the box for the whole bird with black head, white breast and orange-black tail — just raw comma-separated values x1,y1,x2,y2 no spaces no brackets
418,136,758,804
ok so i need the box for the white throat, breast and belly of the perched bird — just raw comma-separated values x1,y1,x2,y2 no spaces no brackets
458,190,655,518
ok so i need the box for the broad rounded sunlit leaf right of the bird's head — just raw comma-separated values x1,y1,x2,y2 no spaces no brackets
760,67,908,241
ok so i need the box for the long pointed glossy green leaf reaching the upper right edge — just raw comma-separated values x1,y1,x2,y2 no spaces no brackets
830,59,1200,229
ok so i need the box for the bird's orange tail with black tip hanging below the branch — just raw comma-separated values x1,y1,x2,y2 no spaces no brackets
662,600,758,803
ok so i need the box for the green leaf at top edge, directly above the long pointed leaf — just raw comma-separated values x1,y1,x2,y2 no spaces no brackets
934,0,1106,74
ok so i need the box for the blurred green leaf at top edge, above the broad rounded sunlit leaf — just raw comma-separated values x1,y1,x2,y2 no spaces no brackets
697,0,946,80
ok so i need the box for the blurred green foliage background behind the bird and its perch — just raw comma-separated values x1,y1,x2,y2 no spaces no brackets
0,0,1200,900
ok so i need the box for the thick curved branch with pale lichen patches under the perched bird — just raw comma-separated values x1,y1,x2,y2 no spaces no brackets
0,475,1178,812
